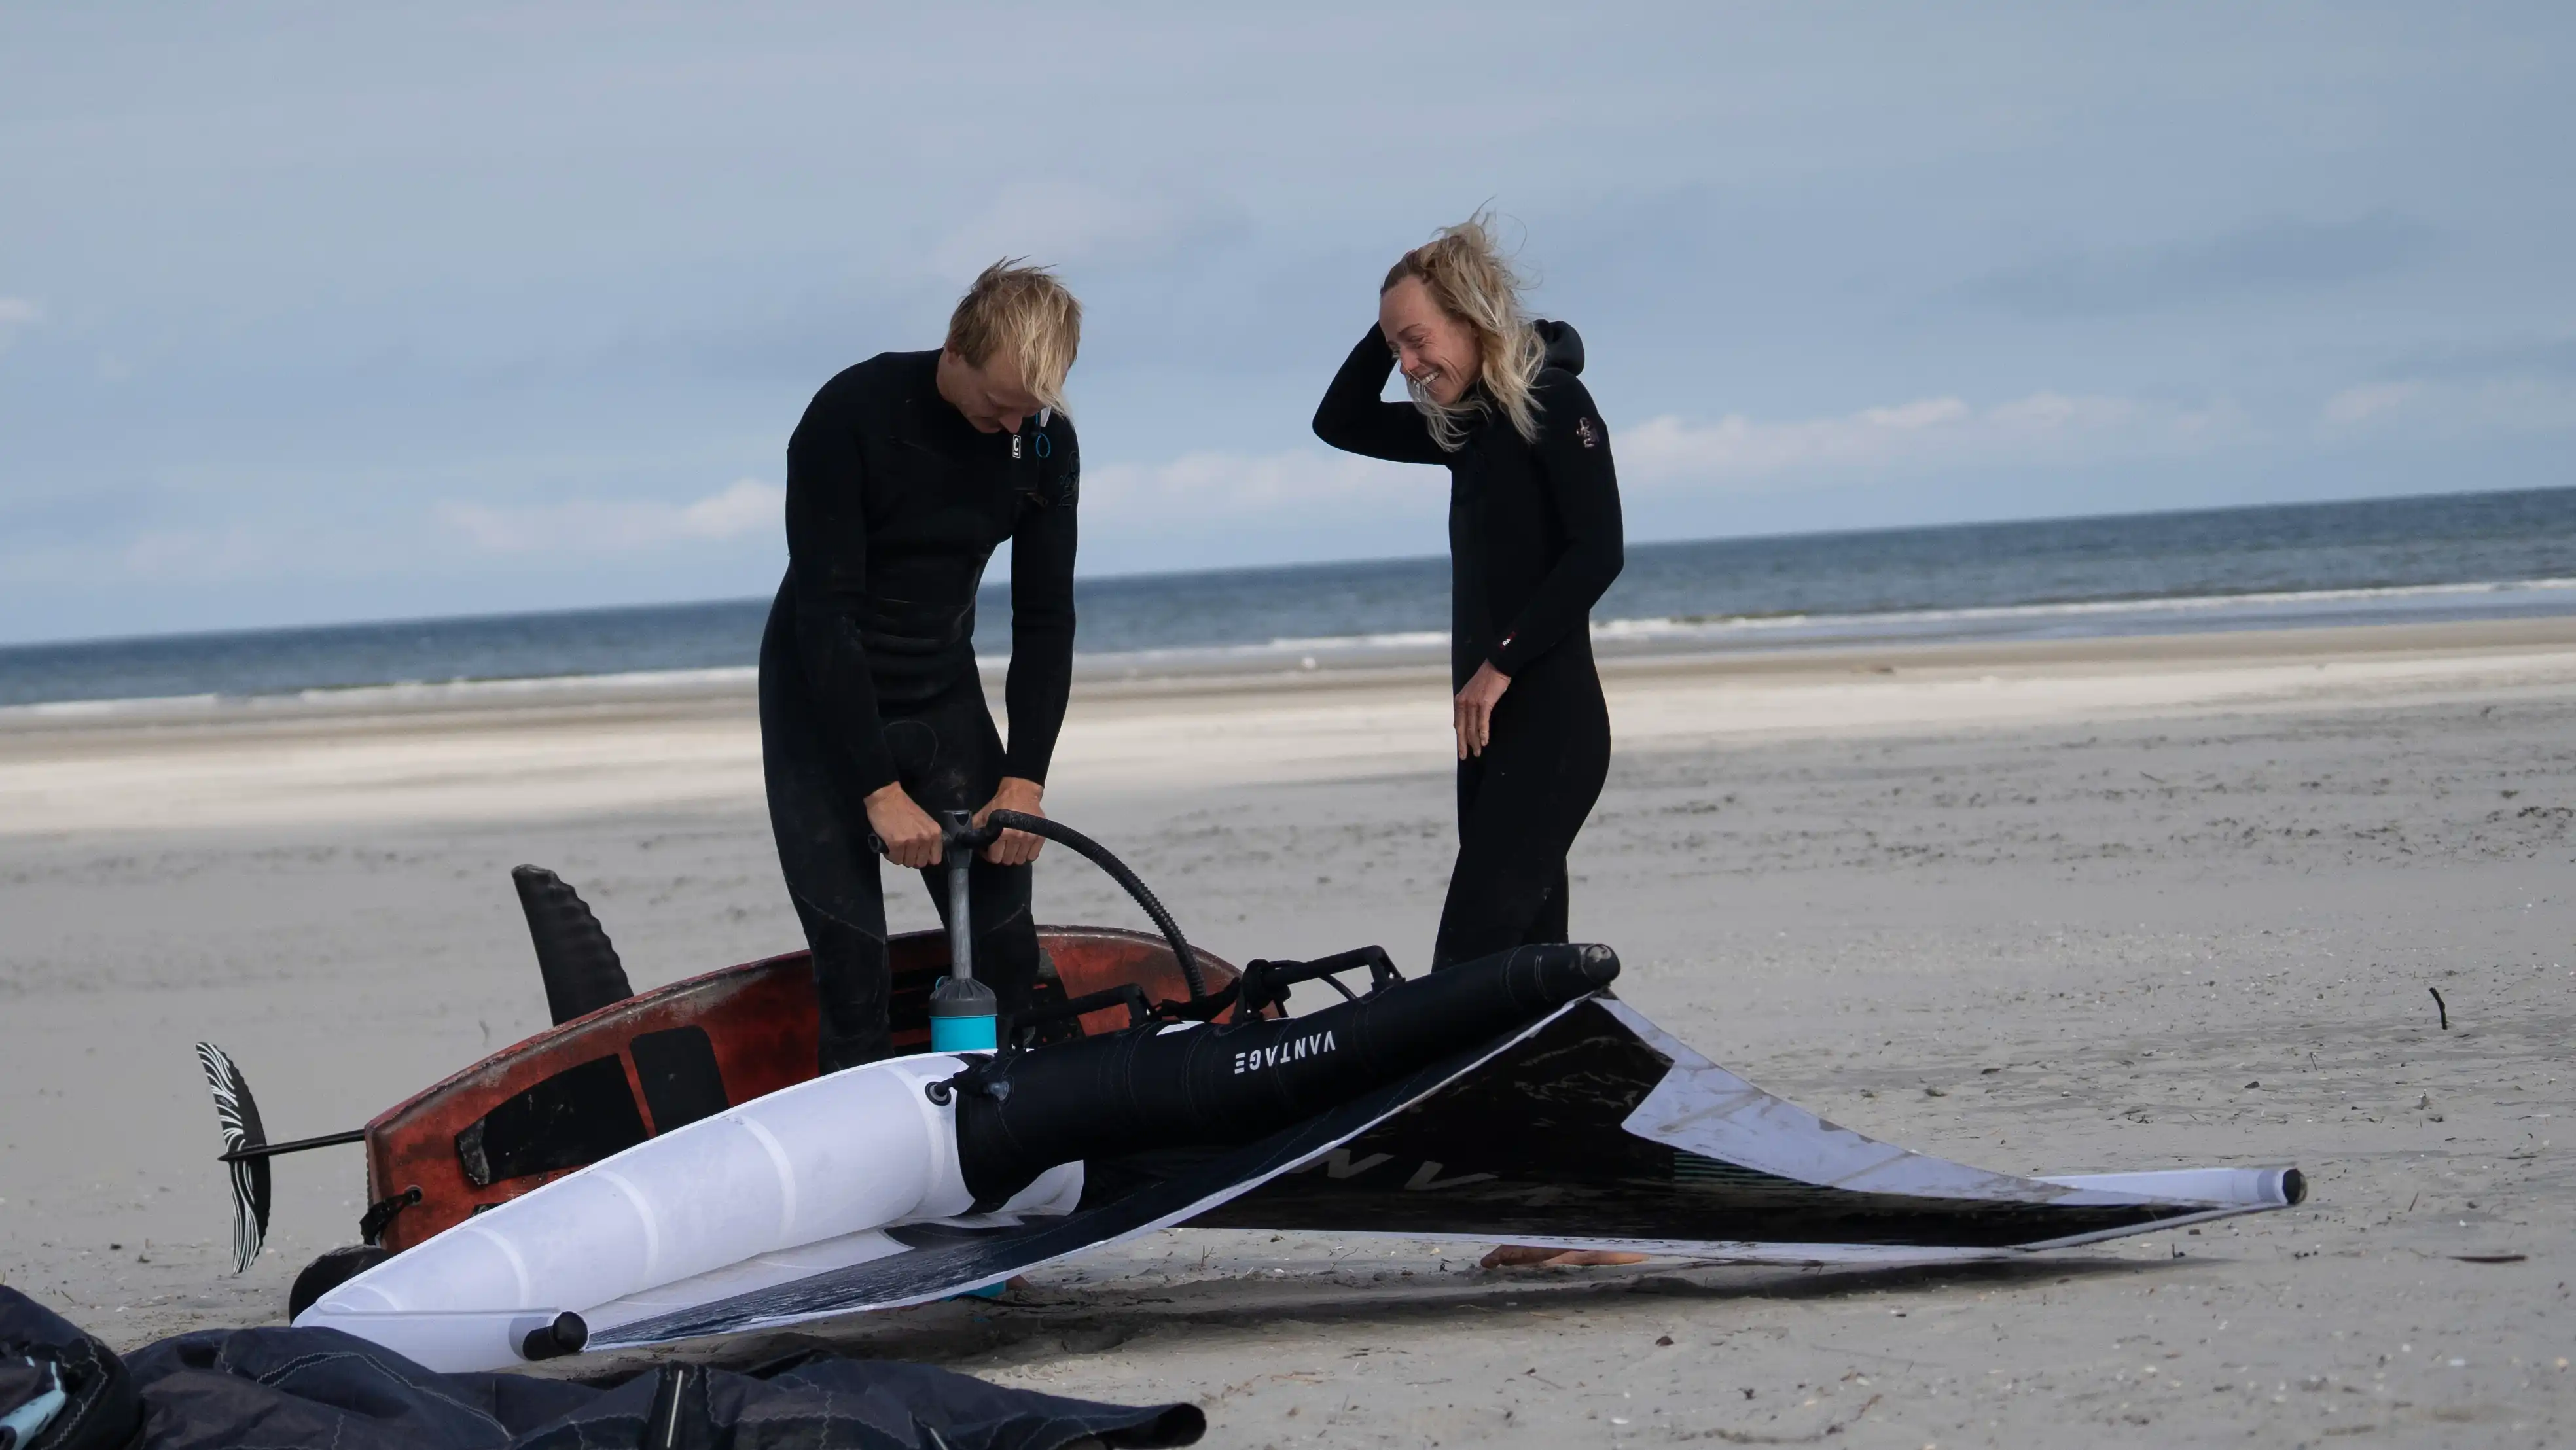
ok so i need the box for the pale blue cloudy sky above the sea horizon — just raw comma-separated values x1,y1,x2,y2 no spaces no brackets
0,0,2576,641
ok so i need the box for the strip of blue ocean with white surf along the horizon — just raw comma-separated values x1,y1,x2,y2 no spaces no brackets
15,489,2576,705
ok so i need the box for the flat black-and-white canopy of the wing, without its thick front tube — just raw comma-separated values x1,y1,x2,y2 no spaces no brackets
590,994,2303,1349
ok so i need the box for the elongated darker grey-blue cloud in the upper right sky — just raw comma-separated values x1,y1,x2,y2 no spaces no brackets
1968,211,2442,317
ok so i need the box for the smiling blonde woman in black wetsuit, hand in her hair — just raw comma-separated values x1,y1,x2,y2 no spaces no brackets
1314,217,1620,971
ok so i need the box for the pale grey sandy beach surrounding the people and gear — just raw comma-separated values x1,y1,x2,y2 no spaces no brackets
0,624,2576,1447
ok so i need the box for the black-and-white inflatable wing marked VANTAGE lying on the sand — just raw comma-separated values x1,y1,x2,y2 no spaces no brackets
296,947,2303,1370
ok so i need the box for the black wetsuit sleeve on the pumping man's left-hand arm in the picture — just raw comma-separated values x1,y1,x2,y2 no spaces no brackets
788,389,894,793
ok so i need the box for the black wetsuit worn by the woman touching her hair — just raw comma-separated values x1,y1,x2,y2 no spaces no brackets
1314,322,1620,968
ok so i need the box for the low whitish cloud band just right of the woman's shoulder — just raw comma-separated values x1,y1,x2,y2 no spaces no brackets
1615,391,2236,489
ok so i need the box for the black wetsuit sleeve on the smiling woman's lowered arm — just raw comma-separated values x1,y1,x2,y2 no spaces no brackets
1486,374,1623,675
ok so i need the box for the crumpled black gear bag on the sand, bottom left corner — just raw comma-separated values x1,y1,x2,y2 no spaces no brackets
0,1288,1208,1450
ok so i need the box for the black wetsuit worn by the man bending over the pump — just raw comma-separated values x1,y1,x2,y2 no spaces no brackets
760,353,1082,1071
